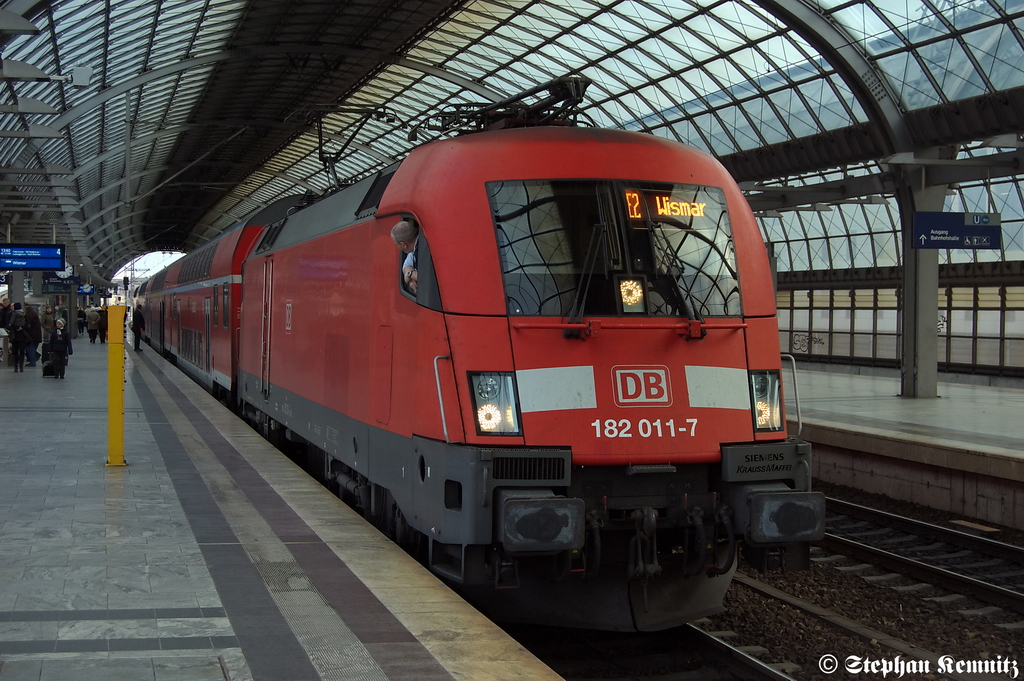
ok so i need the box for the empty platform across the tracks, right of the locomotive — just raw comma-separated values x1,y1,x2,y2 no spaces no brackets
783,367,1024,529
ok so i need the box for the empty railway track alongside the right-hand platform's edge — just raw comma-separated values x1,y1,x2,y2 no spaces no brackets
819,499,1024,629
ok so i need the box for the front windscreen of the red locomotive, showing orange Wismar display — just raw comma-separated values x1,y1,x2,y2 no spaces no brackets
487,180,742,318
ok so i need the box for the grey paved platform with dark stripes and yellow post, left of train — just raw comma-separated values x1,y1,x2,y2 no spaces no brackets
0,337,560,681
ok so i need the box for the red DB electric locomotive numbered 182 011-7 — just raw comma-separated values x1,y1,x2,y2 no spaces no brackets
138,83,824,630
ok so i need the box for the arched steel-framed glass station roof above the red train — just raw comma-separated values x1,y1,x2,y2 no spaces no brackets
0,0,1024,275
